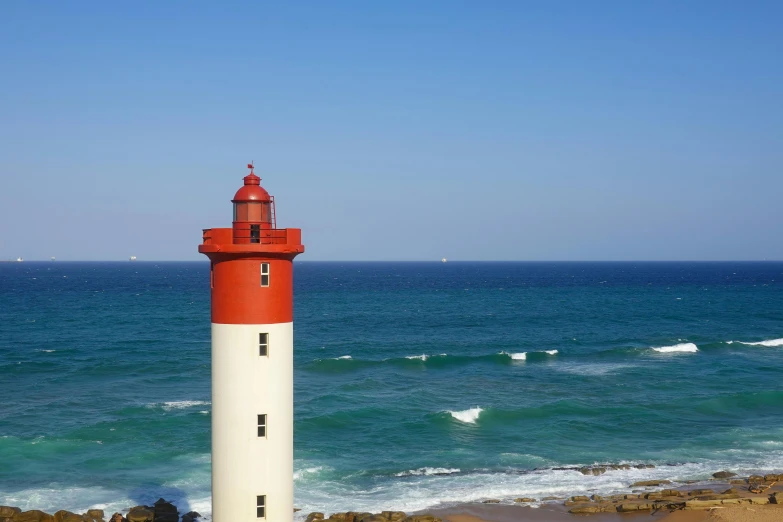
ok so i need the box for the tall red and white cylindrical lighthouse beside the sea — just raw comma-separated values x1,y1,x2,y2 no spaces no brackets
198,165,304,522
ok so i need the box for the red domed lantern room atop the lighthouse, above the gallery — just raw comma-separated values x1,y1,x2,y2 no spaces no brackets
231,164,277,244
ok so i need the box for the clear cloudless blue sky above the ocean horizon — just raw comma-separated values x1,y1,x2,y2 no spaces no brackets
0,0,783,260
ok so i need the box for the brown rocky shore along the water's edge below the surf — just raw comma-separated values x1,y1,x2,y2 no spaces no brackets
0,464,783,522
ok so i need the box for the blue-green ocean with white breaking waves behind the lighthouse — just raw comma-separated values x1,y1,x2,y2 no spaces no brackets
0,261,783,519
